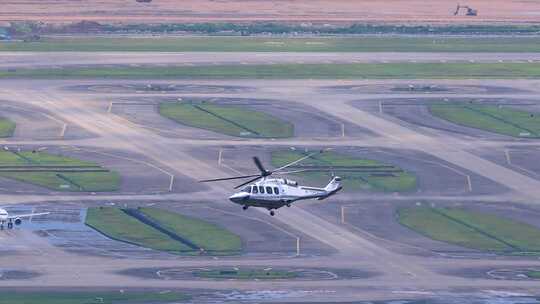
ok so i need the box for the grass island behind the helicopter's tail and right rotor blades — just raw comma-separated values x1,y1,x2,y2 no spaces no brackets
272,151,417,192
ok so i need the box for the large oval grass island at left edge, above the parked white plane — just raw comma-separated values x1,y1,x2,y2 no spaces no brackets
0,151,121,192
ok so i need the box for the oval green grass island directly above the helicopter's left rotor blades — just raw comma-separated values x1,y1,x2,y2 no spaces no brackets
159,103,294,138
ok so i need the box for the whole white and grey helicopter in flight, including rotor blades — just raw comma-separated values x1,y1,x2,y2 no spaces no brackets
199,150,342,216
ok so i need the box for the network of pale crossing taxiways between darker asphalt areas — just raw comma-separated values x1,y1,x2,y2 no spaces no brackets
0,60,540,301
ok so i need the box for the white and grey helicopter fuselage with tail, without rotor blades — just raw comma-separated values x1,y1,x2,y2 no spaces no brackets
229,177,341,210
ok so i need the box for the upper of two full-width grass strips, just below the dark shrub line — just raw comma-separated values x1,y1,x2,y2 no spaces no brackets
5,37,540,52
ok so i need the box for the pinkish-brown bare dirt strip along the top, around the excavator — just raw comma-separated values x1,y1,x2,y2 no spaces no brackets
0,0,540,24
